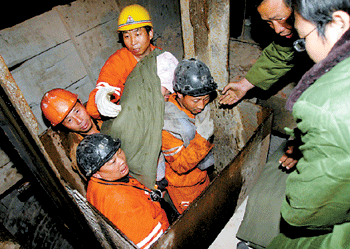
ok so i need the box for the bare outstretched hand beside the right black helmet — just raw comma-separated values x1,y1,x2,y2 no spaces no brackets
219,78,254,105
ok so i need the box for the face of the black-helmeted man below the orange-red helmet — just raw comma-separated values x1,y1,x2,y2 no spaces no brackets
93,148,129,181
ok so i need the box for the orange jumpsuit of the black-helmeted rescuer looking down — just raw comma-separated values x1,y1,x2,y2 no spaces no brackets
162,93,214,213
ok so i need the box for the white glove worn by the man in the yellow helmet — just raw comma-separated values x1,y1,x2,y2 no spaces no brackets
95,82,122,118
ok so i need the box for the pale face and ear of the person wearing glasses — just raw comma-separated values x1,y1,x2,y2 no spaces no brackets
295,13,337,63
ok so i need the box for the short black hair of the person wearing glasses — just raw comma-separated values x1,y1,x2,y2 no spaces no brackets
292,0,350,37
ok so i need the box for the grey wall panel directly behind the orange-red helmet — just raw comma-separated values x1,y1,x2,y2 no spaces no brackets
12,41,94,133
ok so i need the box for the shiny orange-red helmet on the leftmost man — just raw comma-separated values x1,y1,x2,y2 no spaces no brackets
40,88,78,126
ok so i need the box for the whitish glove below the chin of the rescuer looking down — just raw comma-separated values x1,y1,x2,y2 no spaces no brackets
195,105,214,140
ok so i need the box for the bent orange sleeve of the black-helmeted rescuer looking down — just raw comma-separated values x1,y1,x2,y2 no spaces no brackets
162,130,214,174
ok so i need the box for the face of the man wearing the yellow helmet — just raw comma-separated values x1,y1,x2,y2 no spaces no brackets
123,27,153,61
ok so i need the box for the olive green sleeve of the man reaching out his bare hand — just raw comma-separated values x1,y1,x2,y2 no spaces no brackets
245,42,295,90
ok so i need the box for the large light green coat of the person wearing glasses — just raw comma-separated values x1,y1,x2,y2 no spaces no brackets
268,57,350,249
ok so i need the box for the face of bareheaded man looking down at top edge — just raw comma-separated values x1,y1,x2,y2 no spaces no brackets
258,0,293,38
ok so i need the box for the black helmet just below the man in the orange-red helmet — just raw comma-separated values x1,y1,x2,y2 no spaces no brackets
77,133,121,177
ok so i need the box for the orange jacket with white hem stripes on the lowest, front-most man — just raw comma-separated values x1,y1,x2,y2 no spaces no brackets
86,177,169,248
